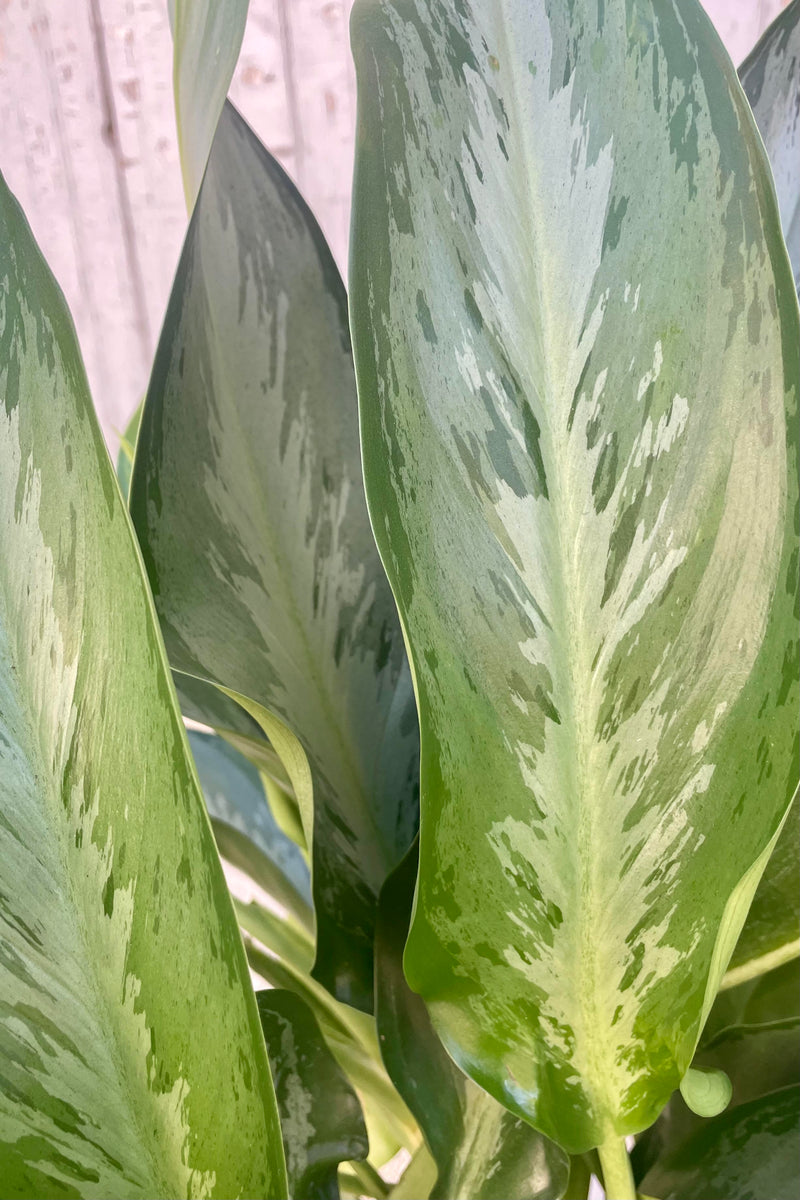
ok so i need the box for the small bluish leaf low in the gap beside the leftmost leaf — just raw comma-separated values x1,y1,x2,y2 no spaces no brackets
188,730,313,929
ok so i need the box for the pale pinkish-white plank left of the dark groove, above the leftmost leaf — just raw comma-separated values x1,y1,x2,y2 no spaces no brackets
0,0,148,442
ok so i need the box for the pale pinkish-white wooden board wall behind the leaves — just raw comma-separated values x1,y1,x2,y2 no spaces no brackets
0,0,784,451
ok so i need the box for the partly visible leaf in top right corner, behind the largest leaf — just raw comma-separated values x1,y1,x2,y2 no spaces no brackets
739,0,800,290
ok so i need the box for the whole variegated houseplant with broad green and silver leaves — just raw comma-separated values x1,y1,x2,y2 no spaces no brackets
0,0,800,1200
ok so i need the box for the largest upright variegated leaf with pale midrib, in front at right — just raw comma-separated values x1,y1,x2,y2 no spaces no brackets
351,0,799,1153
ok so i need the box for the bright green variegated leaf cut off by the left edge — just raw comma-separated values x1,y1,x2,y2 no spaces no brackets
0,178,285,1198
